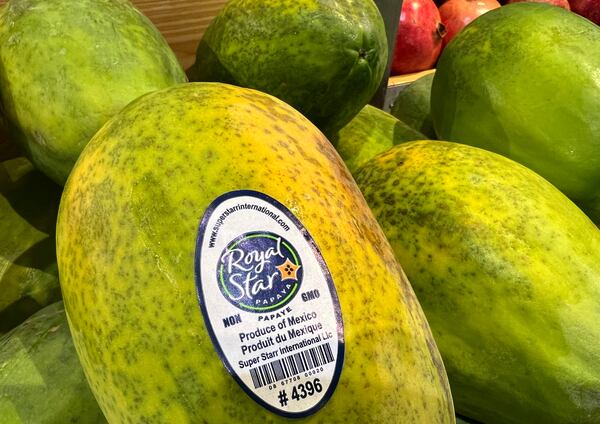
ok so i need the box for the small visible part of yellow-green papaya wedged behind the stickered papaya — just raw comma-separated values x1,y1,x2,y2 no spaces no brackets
330,105,427,173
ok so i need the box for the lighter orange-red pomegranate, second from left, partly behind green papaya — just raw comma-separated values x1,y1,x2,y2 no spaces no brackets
440,0,500,47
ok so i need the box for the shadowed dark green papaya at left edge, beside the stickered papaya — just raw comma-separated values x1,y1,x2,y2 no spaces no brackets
0,157,62,334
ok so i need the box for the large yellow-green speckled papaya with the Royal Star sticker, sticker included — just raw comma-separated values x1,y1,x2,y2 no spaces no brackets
57,83,454,424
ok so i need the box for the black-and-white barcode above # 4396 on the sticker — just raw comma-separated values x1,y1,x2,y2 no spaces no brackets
250,343,335,389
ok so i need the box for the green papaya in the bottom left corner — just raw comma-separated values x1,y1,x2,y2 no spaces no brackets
0,302,106,424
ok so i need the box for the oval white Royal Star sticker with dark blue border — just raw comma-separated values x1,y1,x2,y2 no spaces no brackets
195,190,344,417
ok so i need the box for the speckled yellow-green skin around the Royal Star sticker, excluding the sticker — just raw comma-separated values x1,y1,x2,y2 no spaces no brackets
57,83,454,424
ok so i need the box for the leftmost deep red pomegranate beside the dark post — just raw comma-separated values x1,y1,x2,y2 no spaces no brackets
392,0,445,75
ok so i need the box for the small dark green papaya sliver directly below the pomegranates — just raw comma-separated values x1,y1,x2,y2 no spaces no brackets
390,73,437,140
